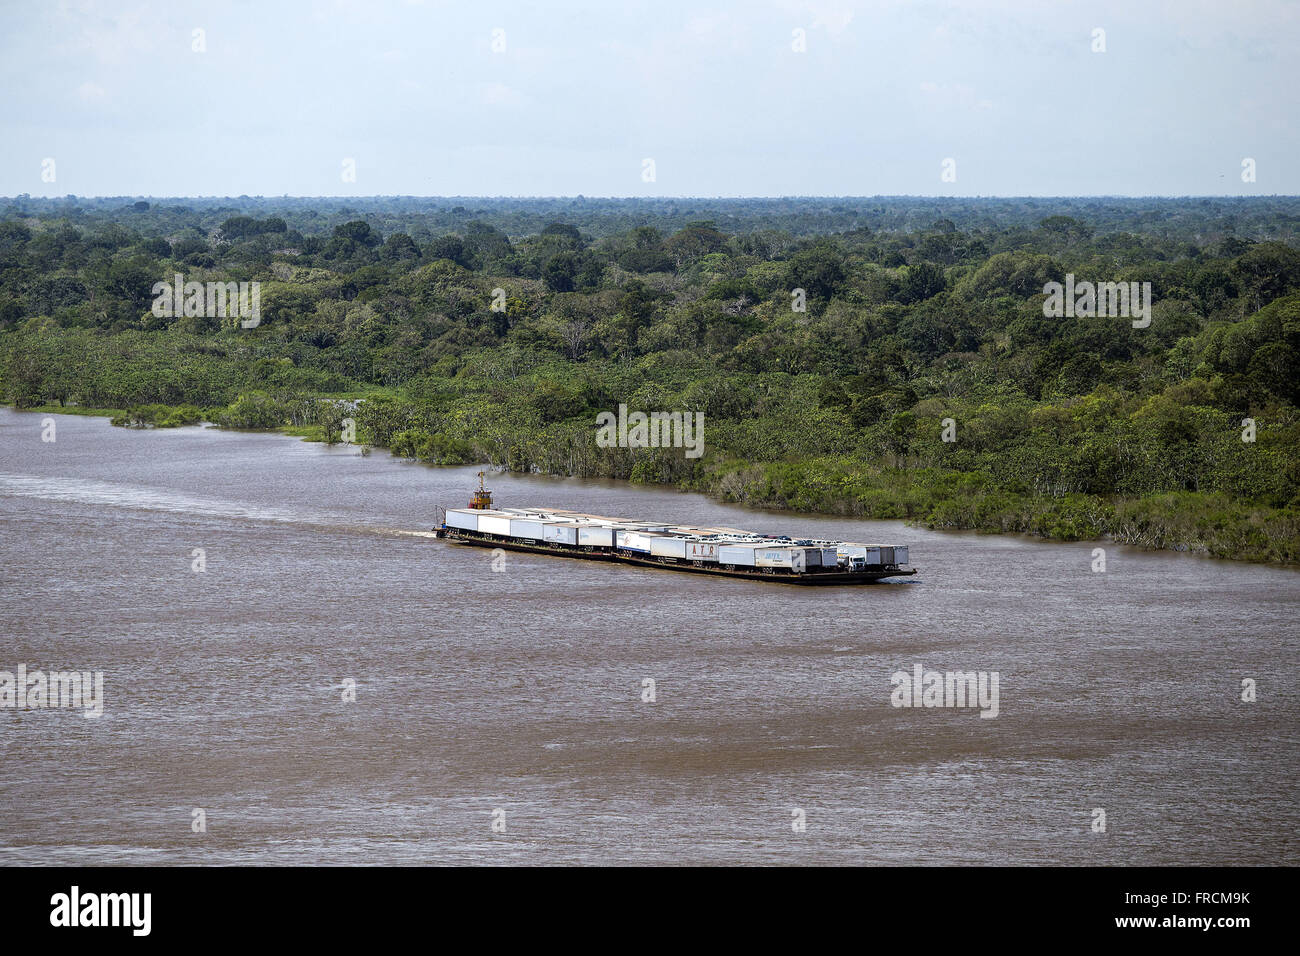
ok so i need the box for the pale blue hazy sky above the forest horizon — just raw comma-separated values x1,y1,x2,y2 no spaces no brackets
0,0,1300,196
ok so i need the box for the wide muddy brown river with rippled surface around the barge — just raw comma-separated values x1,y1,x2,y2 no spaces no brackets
0,408,1300,865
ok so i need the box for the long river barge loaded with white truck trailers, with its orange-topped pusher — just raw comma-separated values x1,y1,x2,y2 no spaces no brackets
433,472,917,585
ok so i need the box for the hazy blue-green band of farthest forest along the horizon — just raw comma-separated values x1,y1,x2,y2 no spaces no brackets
0,196,1300,243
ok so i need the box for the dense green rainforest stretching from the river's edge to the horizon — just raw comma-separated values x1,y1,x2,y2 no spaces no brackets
0,198,1300,563
